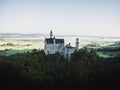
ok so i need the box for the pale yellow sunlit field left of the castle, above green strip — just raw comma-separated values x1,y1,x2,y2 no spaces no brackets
0,38,44,50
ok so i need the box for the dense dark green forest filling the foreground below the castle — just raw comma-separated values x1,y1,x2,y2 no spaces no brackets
0,49,120,90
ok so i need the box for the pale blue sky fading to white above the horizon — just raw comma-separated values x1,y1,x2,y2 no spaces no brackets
0,0,120,37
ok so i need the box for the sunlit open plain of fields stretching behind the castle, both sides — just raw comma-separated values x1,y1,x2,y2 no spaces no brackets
0,36,120,58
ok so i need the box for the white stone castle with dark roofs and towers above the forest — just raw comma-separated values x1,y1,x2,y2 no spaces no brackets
44,31,79,59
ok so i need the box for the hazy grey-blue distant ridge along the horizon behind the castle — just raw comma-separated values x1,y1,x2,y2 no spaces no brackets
0,33,120,38
